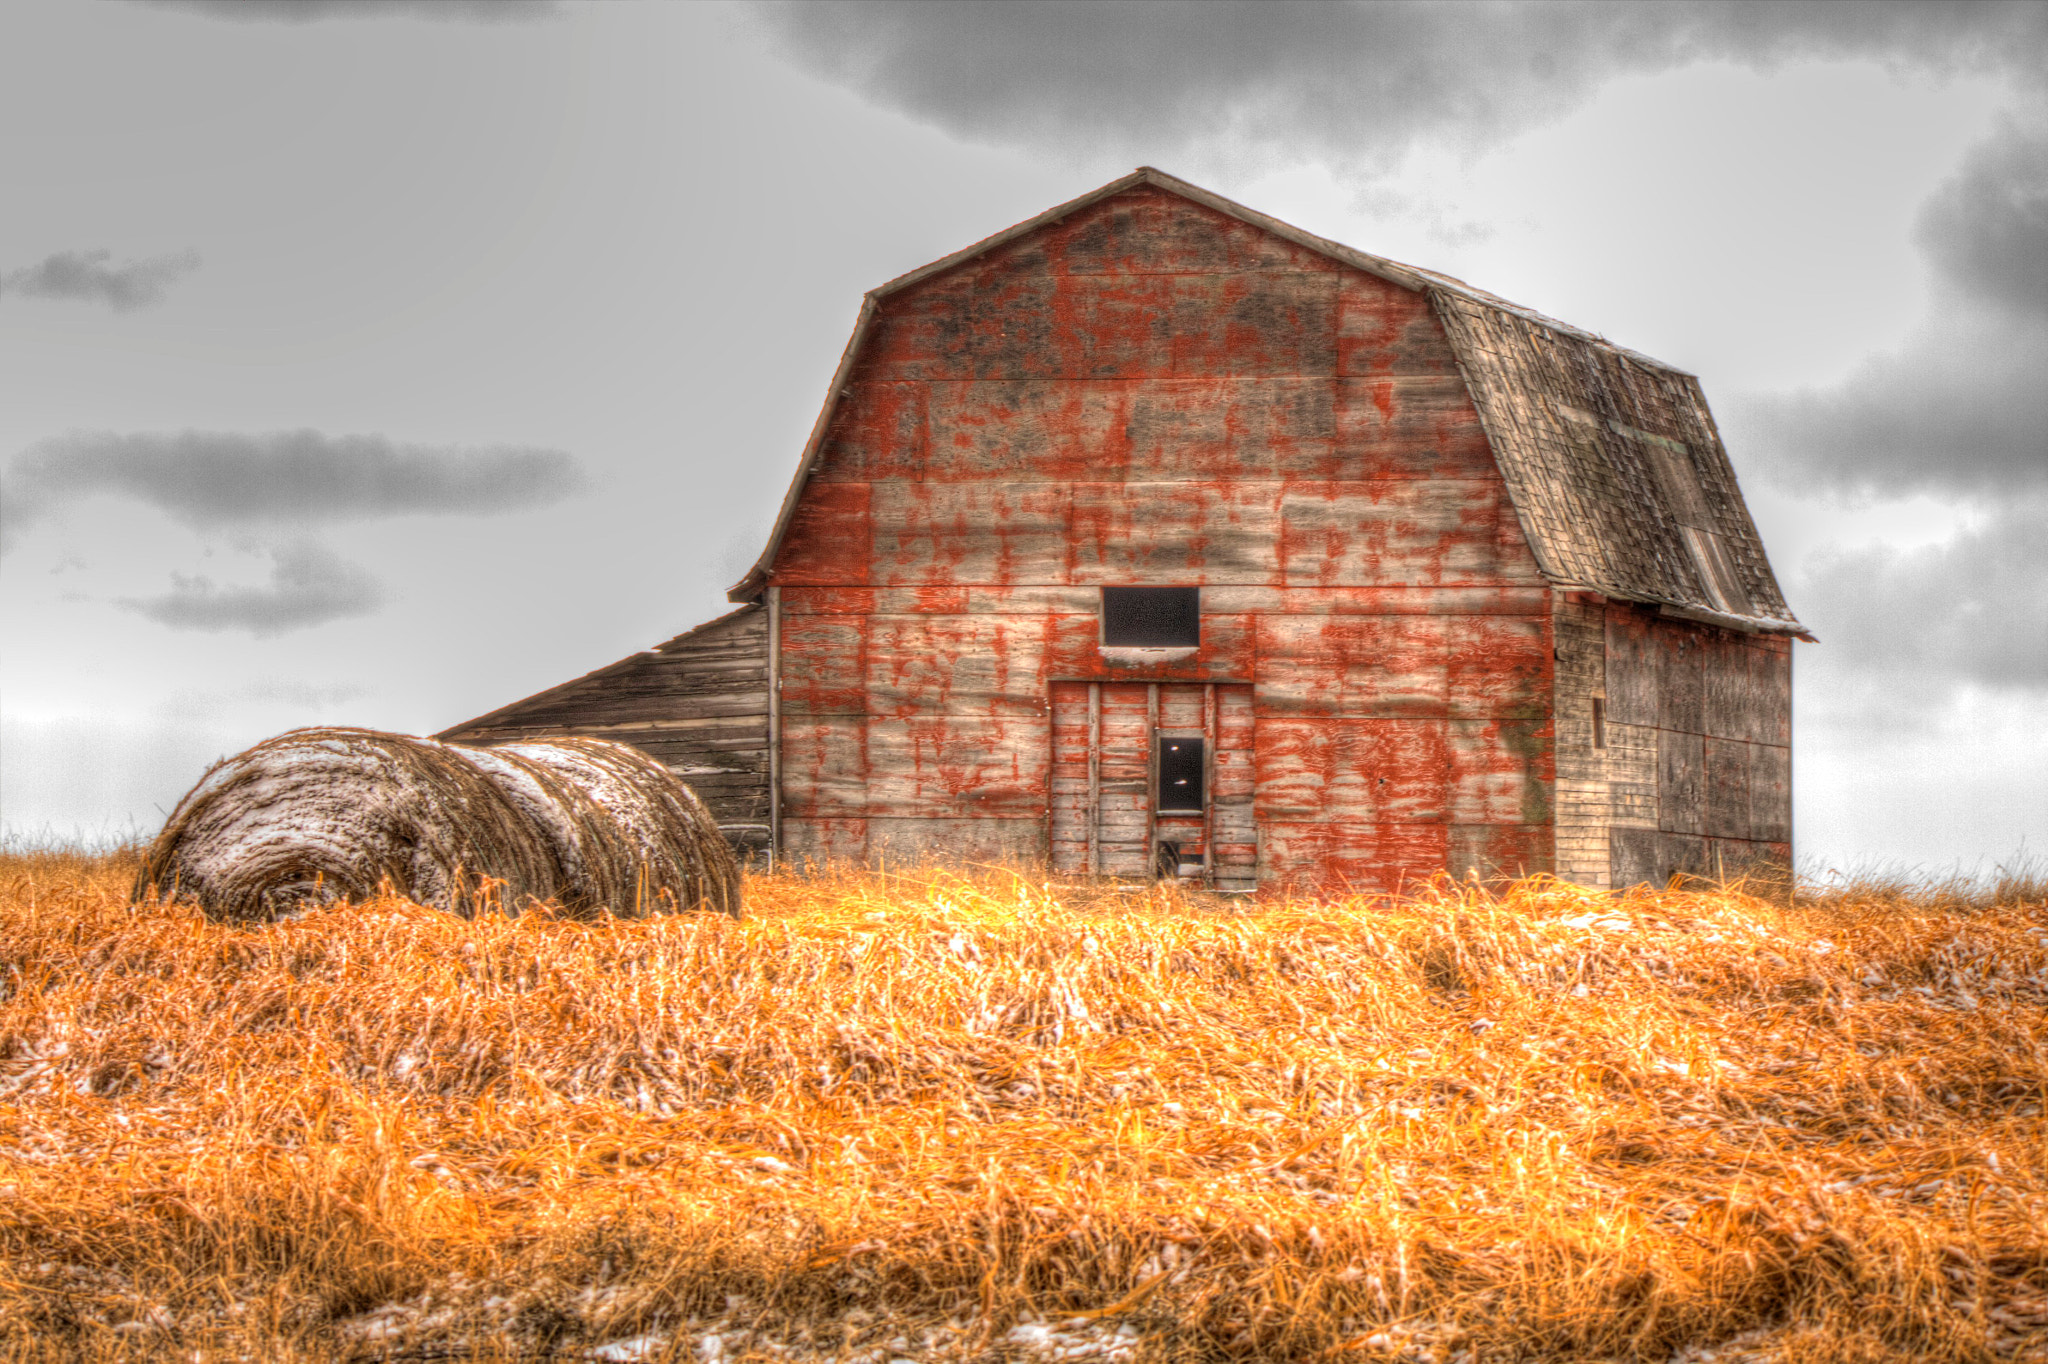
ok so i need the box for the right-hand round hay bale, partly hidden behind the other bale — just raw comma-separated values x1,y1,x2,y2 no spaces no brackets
469,737,739,918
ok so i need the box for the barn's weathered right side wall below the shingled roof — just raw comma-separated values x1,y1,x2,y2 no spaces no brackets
1556,594,1792,887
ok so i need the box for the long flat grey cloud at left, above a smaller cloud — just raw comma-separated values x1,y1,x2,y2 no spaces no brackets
0,430,584,544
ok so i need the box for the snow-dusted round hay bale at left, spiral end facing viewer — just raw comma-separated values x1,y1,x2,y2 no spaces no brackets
135,729,561,920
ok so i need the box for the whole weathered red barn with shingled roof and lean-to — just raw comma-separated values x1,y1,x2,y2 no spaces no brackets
442,168,1808,891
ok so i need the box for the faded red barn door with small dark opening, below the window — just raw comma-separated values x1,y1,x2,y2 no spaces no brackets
1049,682,1257,891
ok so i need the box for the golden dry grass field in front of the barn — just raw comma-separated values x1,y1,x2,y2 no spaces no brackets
0,852,2048,1364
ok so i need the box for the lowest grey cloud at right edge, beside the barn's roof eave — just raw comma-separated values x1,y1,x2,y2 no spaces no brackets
1794,496,2048,702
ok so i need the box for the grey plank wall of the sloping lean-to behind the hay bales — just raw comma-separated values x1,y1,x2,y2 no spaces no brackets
440,608,770,856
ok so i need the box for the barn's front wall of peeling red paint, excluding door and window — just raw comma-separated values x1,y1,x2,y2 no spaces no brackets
770,188,1552,889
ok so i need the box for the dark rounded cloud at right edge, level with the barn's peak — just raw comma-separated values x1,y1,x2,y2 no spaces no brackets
1919,123,2048,319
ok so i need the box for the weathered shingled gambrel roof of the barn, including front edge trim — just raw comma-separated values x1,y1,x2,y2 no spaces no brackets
727,166,1808,637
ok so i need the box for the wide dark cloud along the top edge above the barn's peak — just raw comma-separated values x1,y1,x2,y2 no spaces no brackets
754,0,2048,166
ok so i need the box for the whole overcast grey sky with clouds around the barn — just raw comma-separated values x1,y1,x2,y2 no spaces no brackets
0,0,2048,872
